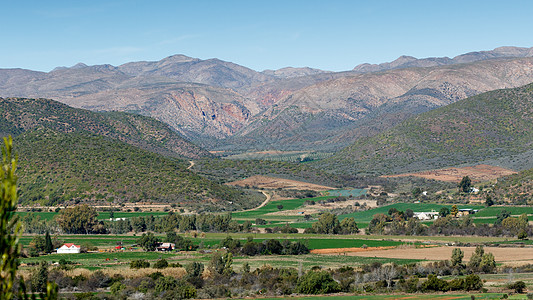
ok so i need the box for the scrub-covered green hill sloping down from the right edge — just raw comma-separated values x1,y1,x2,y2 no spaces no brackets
318,84,533,174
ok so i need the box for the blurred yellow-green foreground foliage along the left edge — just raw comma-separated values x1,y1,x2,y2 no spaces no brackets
0,137,57,300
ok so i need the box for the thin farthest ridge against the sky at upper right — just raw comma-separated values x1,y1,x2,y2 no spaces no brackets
353,47,533,73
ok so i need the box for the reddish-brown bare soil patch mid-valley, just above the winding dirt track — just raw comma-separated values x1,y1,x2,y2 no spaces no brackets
226,175,335,192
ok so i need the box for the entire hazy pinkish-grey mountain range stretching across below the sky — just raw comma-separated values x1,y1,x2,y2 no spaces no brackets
0,47,533,151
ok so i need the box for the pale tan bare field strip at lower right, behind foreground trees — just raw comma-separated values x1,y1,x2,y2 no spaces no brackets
340,246,533,263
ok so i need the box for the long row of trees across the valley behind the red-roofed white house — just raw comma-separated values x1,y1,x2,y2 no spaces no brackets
21,205,359,234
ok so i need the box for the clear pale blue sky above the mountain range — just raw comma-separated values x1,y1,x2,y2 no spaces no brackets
0,0,533,71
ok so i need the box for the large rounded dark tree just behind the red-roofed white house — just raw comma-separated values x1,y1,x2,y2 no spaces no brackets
56,204,98,234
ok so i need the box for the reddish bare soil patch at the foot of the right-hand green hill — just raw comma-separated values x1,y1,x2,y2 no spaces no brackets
382,165,517,182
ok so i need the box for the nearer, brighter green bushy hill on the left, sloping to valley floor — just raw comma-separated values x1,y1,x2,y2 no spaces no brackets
14,127,260,210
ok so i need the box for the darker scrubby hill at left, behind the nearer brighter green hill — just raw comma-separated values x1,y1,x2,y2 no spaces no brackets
0,98,210,158
